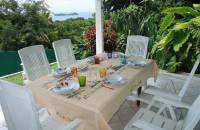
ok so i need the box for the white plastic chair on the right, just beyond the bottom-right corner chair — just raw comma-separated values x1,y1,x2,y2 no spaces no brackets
127,55,200,120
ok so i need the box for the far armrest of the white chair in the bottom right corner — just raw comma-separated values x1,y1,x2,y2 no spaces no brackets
153,96,190,109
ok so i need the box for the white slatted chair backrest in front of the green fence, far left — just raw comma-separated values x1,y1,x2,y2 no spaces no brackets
18,45,51,81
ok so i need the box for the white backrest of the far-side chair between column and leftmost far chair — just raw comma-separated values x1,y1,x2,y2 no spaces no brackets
53,39,76,68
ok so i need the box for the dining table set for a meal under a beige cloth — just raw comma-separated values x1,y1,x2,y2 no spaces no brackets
27,56,158,130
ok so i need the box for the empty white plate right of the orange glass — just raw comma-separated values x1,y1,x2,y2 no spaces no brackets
105,74,125,85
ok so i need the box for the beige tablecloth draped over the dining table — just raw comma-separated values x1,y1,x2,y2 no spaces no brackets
28,59,158,130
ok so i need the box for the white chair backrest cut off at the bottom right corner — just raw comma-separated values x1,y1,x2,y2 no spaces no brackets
183,95,200,130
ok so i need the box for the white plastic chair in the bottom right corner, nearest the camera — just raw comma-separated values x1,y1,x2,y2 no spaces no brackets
124,96,200,130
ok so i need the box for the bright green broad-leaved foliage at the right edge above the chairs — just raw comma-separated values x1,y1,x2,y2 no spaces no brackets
151,4,200,72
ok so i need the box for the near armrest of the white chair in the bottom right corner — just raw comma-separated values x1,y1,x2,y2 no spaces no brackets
132,120,165,130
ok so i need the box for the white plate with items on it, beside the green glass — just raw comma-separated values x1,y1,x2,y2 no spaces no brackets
49,83,80,94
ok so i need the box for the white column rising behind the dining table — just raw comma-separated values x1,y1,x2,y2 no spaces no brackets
95,0,104,54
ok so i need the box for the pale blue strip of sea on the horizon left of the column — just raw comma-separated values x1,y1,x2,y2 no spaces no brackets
51,12,94,21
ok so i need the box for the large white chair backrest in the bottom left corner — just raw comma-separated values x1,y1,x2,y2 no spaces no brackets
0,81,41,130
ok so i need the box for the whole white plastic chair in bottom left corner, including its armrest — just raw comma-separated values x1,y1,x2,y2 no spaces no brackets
0,81,80,130
